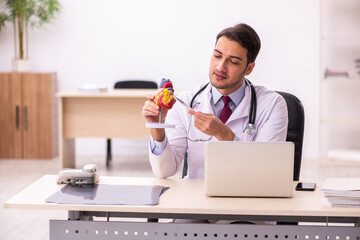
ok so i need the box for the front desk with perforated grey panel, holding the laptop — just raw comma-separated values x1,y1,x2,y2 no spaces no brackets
4,175,360,240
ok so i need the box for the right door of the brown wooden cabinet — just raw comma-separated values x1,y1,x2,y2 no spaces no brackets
22,73,54,158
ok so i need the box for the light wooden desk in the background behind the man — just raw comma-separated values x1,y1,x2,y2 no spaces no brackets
57,89,154,168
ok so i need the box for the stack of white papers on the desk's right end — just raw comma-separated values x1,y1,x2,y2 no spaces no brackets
321,178,360,207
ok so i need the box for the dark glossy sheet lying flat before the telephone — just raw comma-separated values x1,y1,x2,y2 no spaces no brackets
46,184,165,206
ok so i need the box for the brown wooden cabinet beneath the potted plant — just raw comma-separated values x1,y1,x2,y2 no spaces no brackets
0,73,58,159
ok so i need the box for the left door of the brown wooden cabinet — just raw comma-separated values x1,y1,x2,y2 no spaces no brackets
0,73,23,158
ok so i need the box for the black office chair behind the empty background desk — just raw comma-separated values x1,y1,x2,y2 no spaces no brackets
106,80,158,167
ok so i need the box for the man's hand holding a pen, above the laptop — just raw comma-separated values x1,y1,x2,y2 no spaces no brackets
189,110,235,141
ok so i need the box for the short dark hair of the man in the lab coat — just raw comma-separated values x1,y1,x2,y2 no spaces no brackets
216,23,261,63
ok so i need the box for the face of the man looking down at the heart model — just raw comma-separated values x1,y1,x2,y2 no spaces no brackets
209,36,255,95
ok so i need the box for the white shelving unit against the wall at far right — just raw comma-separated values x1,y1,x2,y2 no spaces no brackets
318,0,360,161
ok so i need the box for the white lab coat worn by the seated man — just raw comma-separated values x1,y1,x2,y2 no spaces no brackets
149,81,288,178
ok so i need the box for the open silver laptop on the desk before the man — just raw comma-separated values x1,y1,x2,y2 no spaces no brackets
205,141,294,197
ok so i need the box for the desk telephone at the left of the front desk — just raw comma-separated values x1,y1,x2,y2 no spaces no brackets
57,164,99,185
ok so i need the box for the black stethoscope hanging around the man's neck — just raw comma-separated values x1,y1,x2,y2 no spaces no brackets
190,79,257,135
